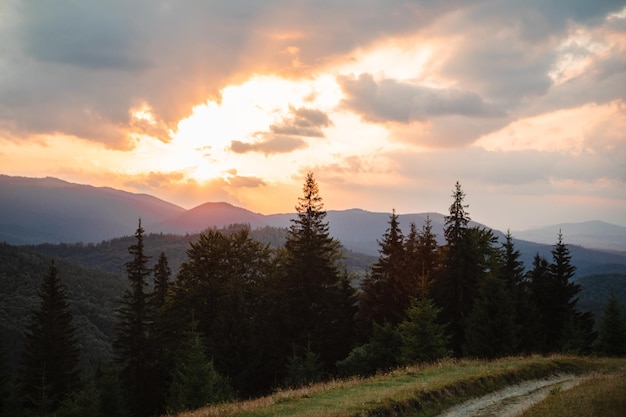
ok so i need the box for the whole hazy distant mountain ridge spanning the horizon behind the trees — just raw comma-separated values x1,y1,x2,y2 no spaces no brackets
0,175,626,273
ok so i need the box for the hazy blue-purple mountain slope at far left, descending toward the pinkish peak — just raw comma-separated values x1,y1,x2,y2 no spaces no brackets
0,175,184,244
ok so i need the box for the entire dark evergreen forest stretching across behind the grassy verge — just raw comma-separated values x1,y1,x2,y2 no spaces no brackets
0,173,626,417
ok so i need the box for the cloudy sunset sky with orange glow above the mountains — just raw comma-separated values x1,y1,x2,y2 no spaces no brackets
0,0,626,230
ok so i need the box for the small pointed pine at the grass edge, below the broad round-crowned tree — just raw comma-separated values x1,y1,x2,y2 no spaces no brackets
166,325,232,414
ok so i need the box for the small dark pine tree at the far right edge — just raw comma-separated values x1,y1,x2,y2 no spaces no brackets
595,294,626,356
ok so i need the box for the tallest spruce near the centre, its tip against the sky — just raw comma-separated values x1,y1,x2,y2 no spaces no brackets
283,172,355,369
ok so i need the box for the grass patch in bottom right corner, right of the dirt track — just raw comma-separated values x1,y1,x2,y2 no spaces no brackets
522,373,626,417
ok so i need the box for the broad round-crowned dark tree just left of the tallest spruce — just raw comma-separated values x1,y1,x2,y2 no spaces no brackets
172,229,276,396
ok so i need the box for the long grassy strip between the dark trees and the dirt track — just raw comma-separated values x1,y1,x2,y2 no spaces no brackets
166,356,626,417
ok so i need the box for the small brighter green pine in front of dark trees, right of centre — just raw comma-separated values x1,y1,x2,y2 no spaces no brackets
398,298,451,364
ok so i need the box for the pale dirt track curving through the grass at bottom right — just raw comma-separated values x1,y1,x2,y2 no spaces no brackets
439,375,585,417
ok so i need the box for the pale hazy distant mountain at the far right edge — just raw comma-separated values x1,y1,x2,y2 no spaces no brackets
513,220,626,253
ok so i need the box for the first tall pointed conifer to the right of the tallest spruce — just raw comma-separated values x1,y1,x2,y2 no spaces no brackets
359,210,408,325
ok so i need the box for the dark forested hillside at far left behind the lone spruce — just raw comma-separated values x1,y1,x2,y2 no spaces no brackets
0,243,127,370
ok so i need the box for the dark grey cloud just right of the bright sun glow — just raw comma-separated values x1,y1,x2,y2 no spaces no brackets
338,74,503,123
